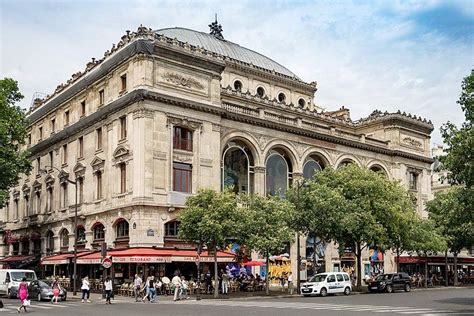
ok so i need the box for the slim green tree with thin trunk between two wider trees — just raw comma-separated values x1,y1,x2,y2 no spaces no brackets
240,195,295,295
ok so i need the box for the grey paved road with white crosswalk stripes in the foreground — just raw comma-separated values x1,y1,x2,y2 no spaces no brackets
0,289,474,316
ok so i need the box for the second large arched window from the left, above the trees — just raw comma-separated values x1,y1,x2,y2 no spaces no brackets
265,150,293,197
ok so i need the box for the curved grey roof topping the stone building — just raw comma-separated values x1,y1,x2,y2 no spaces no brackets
155,27,296,77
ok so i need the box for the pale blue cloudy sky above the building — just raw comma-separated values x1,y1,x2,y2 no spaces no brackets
0,0,474,143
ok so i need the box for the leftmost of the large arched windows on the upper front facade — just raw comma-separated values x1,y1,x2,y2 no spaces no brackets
222,142,254,193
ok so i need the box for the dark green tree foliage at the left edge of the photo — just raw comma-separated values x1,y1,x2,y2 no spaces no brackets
0,78,31,207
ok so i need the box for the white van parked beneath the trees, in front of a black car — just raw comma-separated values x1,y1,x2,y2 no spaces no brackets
300,272,352,296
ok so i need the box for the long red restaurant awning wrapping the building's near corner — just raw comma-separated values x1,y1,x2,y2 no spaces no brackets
77,248,234,264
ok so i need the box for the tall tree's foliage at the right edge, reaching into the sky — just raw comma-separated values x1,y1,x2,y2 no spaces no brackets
440,70,474,188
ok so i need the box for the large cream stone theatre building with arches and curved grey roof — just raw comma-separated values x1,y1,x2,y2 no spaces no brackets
0,23,433,282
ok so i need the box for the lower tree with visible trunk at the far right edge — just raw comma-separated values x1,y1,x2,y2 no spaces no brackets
427,187,474,285
